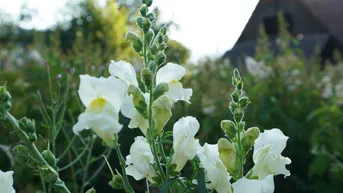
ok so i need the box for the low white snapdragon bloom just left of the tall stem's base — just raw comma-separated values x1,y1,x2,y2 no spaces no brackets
126,136,156,181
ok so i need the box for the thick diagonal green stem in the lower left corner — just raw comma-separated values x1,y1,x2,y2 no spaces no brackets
5,111,70,193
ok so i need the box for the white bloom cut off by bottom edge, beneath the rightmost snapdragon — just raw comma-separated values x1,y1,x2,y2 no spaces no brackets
232,175,275,193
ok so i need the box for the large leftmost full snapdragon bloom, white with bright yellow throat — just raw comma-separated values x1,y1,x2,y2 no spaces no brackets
73,75,125,147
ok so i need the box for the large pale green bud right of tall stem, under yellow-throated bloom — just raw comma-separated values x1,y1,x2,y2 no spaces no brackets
152,95,173,135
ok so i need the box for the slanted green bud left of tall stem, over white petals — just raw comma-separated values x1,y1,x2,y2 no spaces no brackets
128,84,148,118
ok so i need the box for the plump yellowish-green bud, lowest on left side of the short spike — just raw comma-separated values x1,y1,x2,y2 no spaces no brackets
218,138,236,174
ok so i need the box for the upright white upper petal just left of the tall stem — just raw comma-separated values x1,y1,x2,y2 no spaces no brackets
109,60,138,87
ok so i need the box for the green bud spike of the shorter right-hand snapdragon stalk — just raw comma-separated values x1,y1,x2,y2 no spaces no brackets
218,69,260,178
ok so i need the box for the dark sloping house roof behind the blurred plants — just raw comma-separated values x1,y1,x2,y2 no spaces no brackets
223,0,343,62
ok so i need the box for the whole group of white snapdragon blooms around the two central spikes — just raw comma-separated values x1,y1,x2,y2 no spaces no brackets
73,61,291,193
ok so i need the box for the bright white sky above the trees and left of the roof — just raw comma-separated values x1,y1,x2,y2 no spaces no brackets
0,0,258,62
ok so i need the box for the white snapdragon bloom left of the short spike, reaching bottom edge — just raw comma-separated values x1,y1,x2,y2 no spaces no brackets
197,143,232,193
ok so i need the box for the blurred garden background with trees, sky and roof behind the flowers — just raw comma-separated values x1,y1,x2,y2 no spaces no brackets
0,0,343,193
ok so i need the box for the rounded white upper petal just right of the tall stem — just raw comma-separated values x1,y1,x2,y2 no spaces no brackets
156,63,186,85
